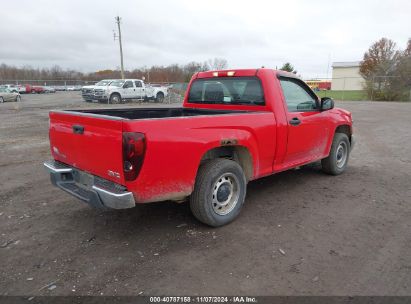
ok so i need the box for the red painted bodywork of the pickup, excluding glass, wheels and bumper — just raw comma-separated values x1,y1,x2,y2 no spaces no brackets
46,69,352,203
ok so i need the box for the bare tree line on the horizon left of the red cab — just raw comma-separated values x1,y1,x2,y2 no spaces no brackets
0,58,228,82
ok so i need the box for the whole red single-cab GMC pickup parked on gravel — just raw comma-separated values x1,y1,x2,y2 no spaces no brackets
44,69,354,226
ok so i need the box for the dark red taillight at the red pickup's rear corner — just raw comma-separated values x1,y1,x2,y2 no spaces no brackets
123,132,146,181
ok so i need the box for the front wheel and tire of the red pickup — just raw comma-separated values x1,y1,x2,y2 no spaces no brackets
321,133,351,175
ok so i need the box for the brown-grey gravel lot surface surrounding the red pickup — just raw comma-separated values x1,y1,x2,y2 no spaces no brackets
0,92,411,295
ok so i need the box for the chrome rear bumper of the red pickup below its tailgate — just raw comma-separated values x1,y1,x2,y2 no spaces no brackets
44,160,136,209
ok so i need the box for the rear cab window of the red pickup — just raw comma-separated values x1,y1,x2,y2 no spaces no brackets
188,77,264,105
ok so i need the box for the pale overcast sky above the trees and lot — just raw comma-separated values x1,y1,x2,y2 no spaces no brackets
0,0,411,78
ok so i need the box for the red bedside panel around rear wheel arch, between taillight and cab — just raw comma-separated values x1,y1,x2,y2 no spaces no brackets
123,112,276,202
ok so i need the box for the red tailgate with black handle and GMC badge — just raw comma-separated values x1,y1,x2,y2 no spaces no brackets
49,111,124,185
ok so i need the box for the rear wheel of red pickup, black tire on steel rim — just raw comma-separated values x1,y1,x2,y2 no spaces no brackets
190,158,247,227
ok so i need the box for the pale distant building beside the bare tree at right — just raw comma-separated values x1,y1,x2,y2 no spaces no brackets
331,61,365,91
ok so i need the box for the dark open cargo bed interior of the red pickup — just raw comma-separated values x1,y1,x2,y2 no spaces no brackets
66,108,250,119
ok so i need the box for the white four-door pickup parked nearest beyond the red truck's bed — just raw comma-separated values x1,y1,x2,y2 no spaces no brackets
89,79,168,103
